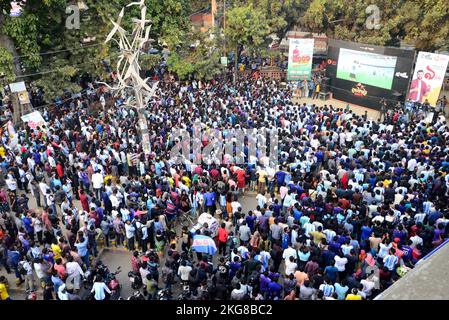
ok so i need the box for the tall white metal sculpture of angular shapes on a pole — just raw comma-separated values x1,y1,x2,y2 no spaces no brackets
102,0,158,154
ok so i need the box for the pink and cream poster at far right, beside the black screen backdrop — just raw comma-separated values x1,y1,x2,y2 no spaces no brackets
408,51,449,106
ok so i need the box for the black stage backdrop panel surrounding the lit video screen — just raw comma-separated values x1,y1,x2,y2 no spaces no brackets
326,40,415,109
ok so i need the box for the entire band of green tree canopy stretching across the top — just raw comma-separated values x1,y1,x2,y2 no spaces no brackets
0,0,449,101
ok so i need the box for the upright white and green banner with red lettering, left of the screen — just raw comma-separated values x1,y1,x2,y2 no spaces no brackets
287,39,315,81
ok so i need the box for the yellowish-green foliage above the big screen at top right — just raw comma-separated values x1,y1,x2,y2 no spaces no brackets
304,0,449,51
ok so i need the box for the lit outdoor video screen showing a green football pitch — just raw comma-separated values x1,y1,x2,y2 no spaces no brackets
337,48,397,90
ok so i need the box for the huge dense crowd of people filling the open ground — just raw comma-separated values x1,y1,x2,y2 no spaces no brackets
0,74,449,300
